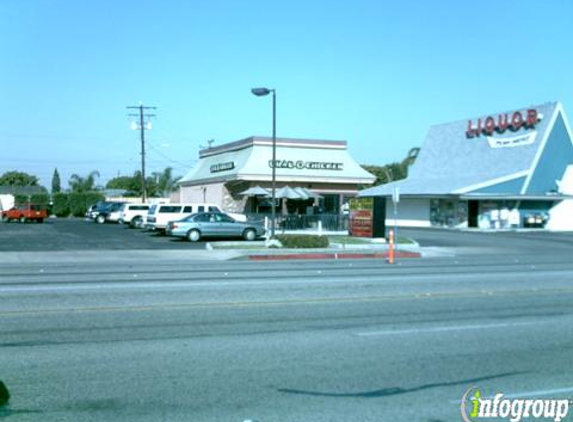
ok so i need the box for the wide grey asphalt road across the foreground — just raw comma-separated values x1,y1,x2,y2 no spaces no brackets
0,247,573,422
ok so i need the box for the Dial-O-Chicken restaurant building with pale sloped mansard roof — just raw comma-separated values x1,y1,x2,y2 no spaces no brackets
172,136,376,218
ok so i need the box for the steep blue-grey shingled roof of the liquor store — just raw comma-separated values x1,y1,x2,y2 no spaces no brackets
359,102,573,196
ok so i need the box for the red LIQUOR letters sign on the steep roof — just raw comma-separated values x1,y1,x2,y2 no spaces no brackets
466,109,542,138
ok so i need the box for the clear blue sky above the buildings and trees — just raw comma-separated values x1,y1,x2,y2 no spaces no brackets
0,0,573,187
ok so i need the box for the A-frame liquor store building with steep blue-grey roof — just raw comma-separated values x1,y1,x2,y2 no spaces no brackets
359,102,573,230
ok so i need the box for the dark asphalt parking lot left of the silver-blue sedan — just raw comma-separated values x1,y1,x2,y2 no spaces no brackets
0,218,205,252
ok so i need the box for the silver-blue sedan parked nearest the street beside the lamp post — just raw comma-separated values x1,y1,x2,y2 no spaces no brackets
165,212,265,242
